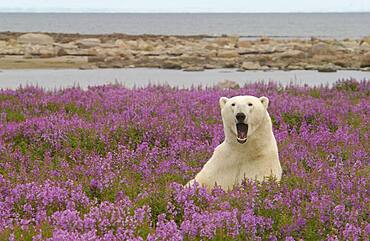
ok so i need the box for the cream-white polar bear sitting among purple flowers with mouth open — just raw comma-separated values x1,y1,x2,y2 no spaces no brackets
187,95,282,190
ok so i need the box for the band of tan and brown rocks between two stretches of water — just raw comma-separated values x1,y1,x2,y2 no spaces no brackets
0,32,370,72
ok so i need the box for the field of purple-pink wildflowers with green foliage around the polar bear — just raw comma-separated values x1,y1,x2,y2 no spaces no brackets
0,80,370,241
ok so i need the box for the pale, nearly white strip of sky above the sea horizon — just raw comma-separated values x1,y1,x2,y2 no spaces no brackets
0,0,370,12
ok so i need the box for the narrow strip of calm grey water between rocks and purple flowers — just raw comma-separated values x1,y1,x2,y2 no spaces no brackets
0,68,370,90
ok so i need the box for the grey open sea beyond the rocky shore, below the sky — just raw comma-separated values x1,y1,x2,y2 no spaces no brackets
0,13,370,39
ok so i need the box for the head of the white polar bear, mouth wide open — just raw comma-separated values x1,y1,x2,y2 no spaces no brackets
220,95,269,144
